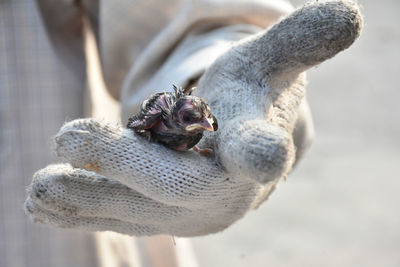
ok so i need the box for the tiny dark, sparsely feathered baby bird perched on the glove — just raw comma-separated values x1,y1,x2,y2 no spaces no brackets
127,85,218,156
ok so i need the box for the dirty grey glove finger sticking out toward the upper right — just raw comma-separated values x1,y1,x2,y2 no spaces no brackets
239,0,362,85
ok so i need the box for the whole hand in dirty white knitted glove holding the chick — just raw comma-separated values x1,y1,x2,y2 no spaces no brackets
25,1,362,236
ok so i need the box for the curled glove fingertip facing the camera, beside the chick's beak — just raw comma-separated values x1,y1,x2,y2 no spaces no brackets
216,117,295,184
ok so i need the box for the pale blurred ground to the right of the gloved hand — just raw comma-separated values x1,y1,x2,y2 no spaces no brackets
192,0,400,267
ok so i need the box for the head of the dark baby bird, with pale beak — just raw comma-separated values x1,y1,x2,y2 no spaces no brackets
172,95,218,134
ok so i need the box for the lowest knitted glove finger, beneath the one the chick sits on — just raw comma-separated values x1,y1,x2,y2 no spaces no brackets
28,164,193,224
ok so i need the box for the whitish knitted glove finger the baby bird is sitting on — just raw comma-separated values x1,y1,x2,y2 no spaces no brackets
55,119,257,209
